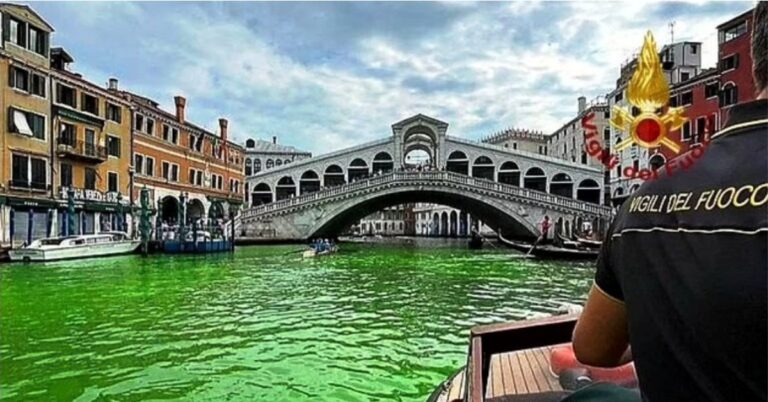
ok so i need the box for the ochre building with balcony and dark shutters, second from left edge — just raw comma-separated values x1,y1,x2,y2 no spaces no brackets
50,48,131,235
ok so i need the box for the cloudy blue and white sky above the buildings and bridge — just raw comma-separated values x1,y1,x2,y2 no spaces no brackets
32,1,754,154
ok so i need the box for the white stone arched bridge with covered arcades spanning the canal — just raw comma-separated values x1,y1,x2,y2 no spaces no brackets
236,114,610,240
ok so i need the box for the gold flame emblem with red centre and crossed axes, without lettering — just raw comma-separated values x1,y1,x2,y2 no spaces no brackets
611,31,688,153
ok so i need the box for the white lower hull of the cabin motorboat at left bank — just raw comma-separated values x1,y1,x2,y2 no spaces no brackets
8,240,141,262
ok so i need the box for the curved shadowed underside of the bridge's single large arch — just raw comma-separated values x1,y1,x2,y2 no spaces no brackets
308,187,538,238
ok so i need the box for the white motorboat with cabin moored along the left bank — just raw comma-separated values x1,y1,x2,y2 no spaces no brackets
8,232,141,261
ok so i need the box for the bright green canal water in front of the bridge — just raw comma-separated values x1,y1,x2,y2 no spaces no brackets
0,242,592,401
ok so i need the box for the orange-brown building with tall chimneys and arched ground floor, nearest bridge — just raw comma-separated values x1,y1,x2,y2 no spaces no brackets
110,89,244,231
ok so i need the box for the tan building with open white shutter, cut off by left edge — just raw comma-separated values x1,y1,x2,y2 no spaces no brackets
0,3,58,245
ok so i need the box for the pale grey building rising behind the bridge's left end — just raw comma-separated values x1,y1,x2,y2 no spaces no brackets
243,136,308,205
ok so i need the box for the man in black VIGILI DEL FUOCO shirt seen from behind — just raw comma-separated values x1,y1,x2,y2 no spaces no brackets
573,2,768,402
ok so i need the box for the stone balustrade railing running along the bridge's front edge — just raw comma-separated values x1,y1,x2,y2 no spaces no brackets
242,171,610,219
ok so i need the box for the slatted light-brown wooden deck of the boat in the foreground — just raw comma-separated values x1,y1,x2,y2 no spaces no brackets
437,345,563,402
